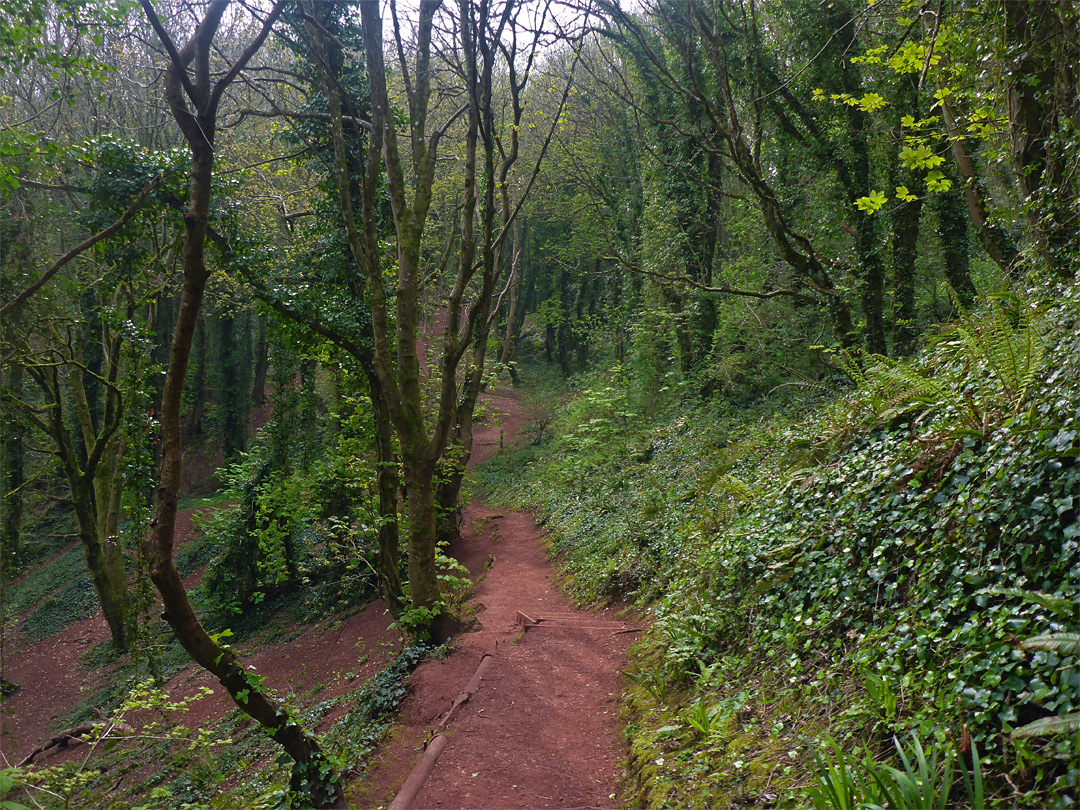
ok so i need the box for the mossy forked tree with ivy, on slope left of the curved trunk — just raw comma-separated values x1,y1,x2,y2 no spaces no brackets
0,141,167,650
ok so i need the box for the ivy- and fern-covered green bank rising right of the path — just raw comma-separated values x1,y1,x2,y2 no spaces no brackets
482,282,1080,808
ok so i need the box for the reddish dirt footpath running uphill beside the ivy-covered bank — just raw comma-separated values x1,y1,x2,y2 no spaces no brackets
376,392,637,810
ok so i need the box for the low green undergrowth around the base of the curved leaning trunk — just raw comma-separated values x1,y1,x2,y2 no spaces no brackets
6,644,445,810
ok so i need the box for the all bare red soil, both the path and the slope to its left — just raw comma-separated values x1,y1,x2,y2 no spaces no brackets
0,391,636,810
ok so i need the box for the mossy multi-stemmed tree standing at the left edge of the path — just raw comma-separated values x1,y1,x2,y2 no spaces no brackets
302,0,578,638
